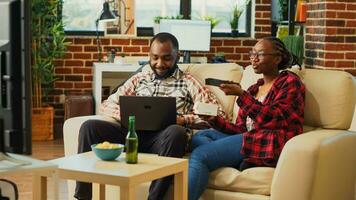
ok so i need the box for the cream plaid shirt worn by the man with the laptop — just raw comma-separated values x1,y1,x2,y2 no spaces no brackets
100,67,223,127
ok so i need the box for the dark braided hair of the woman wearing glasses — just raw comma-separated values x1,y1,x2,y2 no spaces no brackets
262,37,301,70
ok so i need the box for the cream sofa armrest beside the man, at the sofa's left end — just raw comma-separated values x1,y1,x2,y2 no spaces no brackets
63,115,115,156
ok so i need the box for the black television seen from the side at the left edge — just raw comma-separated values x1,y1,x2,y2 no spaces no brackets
0,0,32,160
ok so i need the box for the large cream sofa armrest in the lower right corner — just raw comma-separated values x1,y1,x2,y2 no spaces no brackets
271,129,356,200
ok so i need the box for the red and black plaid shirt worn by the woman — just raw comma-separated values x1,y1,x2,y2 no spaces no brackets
213,71,305,166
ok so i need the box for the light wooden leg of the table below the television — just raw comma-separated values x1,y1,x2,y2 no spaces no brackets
32,174,47,200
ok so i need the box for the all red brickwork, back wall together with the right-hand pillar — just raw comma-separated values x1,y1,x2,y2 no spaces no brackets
48,0,356,136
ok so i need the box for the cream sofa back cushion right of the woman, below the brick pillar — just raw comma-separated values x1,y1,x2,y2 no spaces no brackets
304,69,355,130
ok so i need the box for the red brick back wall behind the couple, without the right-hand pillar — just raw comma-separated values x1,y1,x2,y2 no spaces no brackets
49,0,271,137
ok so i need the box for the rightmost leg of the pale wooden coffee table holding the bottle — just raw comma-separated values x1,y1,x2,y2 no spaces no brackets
174,169,188,200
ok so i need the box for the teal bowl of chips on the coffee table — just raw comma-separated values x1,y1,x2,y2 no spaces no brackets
91,141,124,160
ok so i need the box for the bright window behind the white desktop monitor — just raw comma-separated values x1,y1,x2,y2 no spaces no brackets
135,0,251,36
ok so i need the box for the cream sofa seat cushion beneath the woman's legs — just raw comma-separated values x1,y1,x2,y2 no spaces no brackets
208,167,275,195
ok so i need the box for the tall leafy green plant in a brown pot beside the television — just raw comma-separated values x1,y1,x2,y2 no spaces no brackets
31,0,69,140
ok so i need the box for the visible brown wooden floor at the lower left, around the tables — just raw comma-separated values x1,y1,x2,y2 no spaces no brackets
1,139,68,200
